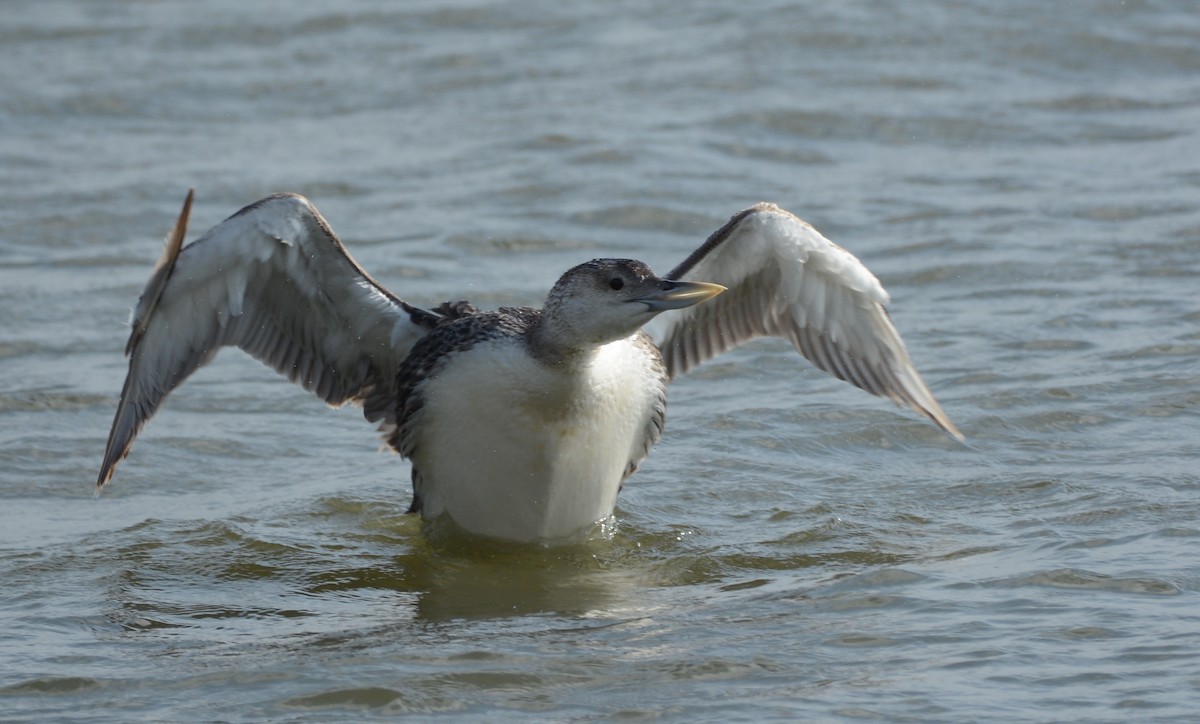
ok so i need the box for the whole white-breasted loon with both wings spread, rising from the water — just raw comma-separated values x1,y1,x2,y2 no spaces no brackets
97,193,960,541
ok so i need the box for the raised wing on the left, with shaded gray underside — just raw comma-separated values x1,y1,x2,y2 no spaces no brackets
96,191,438,490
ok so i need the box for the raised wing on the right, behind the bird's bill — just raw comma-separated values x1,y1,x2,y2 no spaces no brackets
656,204,962,439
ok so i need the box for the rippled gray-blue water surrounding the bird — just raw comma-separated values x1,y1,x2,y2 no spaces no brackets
0,0,1200,722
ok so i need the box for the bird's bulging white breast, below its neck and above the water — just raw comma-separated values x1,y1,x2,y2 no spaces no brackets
413,339,659,541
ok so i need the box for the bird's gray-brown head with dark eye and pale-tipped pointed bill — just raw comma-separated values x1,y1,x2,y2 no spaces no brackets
542,259,725,349
